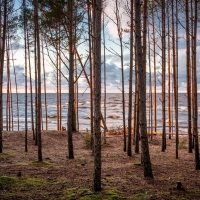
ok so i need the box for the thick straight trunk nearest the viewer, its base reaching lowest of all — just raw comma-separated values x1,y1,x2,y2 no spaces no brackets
93,0,102,192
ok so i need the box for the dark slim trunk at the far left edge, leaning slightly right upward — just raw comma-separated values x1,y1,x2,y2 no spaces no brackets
0,0,7,153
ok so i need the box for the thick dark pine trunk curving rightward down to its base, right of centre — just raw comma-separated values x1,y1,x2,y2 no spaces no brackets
135,0,153,178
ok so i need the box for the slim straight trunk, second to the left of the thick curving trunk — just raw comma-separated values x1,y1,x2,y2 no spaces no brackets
127,0,133,156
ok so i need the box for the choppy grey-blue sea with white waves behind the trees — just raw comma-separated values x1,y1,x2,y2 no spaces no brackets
3,93,200,134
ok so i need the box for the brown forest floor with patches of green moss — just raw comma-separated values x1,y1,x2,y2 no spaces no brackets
0,131,200,200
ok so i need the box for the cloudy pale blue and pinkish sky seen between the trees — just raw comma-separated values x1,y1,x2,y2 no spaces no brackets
4,0,200,93
